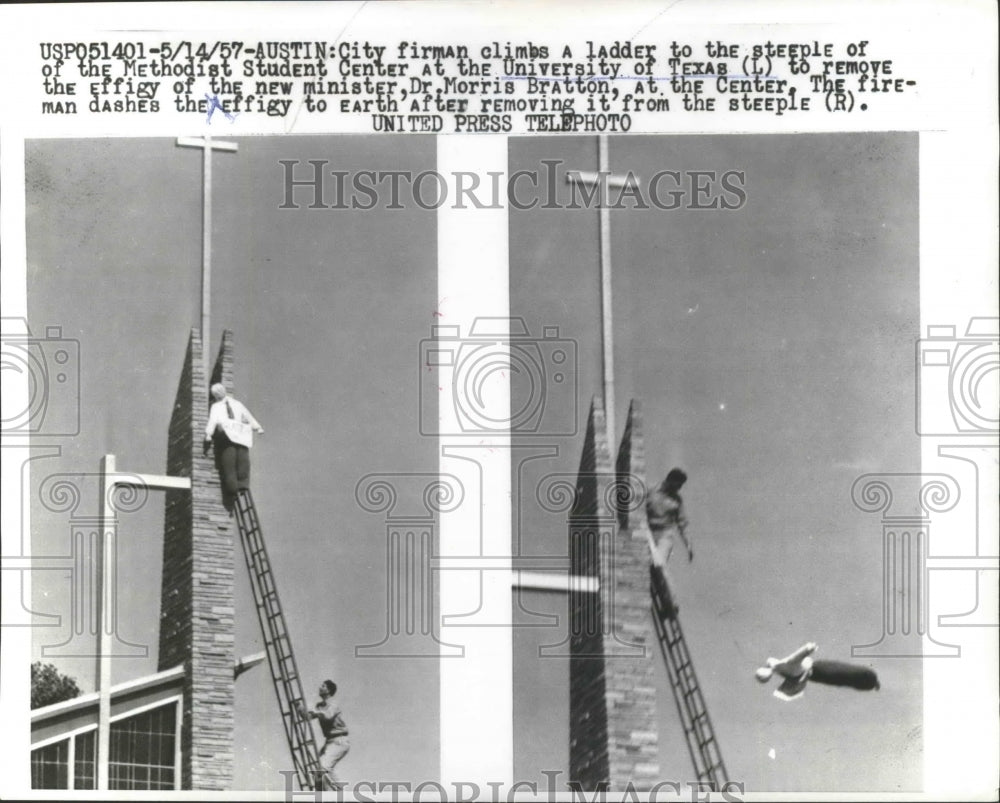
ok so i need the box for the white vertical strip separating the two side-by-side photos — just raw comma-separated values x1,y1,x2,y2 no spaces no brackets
436,135,514,788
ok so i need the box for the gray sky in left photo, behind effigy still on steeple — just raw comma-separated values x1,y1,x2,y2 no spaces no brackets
26,133,439,789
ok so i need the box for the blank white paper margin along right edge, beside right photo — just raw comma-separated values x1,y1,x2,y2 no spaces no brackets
915,125,1000,800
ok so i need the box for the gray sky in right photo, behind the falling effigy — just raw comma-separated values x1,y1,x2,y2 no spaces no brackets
510,134,922,791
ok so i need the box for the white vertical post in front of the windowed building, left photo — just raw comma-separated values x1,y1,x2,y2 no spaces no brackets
95,454,117,791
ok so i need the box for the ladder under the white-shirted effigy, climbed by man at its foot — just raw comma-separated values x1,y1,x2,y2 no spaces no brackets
236,490,322,790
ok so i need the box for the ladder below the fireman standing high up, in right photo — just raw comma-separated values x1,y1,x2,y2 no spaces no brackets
650,566,729,792
